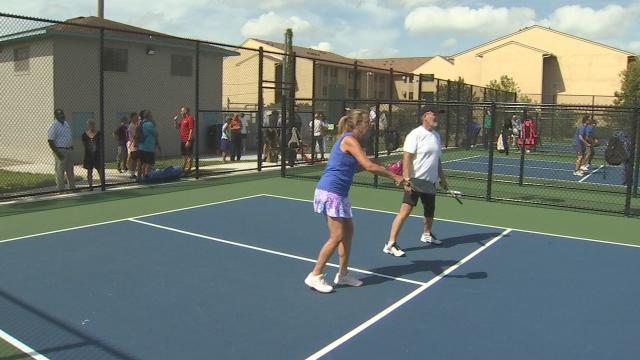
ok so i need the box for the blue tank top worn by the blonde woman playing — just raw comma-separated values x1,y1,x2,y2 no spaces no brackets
316,132,358,197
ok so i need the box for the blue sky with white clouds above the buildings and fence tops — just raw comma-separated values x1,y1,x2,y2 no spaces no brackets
0,0,640,58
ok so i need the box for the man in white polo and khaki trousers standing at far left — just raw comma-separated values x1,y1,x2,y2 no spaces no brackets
47,109,76,191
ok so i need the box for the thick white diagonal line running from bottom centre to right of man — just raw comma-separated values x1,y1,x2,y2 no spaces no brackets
307,229,511,360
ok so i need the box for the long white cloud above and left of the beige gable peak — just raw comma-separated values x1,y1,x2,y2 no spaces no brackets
404,6,536,35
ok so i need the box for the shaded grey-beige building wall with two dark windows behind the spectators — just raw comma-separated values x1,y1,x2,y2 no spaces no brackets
55,37,222,161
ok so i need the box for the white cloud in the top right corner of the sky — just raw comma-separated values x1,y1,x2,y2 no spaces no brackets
540,5,640,38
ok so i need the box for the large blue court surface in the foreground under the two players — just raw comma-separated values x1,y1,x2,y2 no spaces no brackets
0,195,640,359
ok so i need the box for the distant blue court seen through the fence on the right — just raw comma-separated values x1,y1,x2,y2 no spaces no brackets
444,155,624,185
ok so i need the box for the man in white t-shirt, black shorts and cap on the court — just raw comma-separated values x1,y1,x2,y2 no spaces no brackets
382,106,448,256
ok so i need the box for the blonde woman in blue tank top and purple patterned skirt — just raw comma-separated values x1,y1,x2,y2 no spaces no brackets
304,110,405,293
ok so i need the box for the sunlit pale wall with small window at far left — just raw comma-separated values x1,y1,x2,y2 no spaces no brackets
0,39,55,165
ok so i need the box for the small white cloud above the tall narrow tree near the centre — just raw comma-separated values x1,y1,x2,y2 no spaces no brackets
240,11,312,38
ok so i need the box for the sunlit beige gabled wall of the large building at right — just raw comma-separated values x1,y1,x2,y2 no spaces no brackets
452,26,632,102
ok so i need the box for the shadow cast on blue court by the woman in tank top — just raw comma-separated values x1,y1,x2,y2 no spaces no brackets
360,260,458,286
